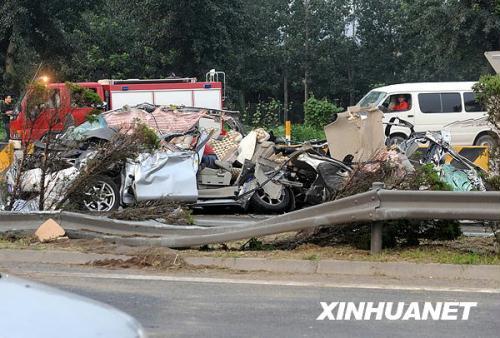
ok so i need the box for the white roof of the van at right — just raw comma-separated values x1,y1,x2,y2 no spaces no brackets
372,81,476,93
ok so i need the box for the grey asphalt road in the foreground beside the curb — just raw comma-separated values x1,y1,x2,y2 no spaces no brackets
10,269,500,337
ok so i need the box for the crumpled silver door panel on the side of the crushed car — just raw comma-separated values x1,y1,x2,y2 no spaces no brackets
125,152,198,202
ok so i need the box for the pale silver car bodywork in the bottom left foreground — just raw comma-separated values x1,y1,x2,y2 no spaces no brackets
0,274,144,338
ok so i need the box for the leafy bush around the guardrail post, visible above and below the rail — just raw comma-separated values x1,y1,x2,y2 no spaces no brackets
292,152,461,249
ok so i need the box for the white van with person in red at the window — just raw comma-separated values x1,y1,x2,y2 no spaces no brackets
358,82,498,147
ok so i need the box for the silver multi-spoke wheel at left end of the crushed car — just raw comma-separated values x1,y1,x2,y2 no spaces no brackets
83,176,120,212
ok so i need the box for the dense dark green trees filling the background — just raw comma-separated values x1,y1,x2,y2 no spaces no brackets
0,0,500,121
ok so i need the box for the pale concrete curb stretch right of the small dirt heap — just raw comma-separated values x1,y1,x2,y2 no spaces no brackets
183,256,500,281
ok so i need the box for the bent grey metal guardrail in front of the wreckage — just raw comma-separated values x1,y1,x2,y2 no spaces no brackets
0,185,500,253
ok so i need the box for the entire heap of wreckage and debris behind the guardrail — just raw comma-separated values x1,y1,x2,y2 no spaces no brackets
0,104,494,218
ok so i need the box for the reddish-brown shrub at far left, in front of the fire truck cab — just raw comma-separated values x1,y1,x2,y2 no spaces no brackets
8,82,102,210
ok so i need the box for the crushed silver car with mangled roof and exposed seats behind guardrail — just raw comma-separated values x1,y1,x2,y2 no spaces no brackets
8,104,351,212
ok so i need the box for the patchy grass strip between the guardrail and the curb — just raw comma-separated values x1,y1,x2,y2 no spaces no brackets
0,237,500,265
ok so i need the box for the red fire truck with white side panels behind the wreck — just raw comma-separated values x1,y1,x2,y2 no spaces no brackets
10,70,224,141
